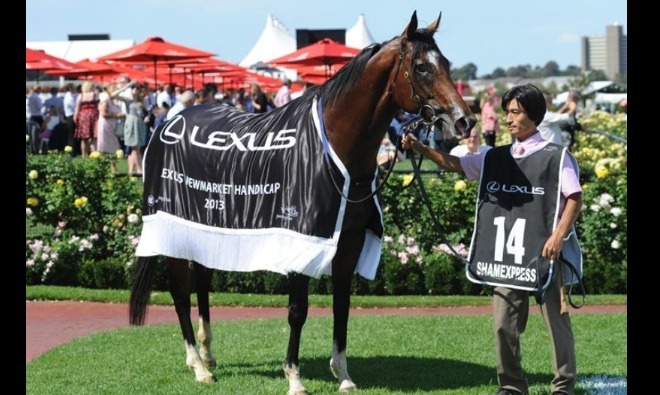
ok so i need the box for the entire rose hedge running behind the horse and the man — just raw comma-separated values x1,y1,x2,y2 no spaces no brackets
25,113,628,295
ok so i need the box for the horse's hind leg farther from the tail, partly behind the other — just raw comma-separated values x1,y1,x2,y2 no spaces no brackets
194,262,216,368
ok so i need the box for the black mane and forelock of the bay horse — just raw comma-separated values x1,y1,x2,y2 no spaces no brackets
301,28,449,107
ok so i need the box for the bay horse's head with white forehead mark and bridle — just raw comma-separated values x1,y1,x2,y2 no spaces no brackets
390,11,477,138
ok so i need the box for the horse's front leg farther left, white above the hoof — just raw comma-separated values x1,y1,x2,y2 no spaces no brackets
284,273,309,395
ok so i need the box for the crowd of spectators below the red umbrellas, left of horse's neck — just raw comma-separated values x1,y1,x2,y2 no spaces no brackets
25,76,304,174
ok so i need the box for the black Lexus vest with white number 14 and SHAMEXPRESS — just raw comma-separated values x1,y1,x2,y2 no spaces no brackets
466,143,565,291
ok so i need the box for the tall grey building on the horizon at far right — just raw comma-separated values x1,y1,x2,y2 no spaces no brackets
582,23,628,81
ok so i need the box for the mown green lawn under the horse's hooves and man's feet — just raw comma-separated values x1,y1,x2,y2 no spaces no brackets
25,313,627,395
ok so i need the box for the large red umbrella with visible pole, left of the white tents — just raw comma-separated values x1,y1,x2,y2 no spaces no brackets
99,37,214,82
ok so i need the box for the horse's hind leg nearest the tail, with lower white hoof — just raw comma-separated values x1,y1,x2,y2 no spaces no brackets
167,258,214,383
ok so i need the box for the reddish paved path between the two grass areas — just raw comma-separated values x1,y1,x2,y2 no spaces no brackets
25,301,628,364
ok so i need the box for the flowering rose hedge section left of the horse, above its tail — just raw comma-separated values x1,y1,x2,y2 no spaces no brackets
25,150,142,288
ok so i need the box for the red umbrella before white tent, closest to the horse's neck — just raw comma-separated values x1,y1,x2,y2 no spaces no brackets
267,38,360,77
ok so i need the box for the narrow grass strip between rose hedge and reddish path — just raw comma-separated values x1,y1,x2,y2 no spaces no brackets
25,285,628,308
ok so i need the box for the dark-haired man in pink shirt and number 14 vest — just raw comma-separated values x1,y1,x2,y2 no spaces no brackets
403,84,582,395
